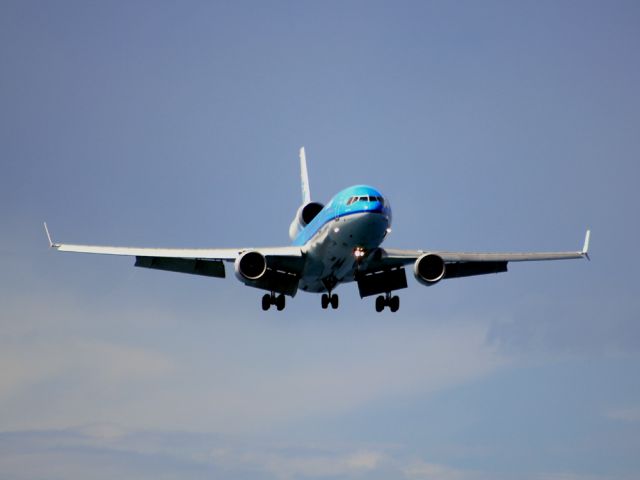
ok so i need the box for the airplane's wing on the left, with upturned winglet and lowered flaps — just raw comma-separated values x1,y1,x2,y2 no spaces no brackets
44,223,304,278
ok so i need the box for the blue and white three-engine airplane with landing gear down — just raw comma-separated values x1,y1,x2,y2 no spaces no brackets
44,147,591,312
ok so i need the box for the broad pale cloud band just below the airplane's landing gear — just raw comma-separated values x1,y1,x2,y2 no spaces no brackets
0,290,505,433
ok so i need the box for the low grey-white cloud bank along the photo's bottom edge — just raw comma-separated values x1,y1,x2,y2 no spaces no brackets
0,425,633,480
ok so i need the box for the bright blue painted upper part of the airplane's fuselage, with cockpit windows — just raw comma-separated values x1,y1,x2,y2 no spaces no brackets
293,185,391,246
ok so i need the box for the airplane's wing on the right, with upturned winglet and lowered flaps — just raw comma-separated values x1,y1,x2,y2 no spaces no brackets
364,230,591,278
